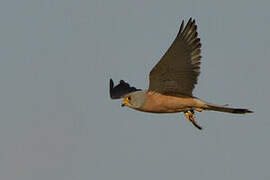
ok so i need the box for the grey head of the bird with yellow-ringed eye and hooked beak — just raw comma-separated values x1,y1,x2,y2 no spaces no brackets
121,91,146,109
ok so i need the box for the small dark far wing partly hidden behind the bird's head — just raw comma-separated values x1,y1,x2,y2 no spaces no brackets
110,79,140,99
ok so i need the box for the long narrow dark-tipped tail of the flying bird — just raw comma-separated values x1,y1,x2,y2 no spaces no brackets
205,103,253,114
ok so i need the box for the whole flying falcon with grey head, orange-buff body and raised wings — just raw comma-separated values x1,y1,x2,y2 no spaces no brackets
110,18,252,129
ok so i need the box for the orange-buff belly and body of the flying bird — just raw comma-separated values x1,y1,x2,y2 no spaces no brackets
138,93,196,113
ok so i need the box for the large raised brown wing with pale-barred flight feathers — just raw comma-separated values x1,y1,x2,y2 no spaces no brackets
149,18,201,96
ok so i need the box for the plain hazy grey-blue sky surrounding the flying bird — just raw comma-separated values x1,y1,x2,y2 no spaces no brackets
0,0,270,180
